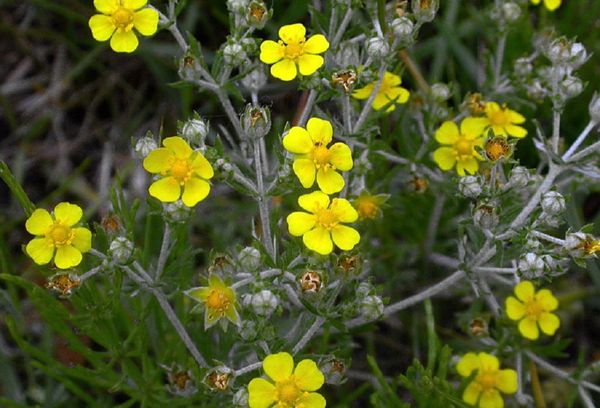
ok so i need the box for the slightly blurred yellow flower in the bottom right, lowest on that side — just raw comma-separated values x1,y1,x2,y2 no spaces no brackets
456,352,518,408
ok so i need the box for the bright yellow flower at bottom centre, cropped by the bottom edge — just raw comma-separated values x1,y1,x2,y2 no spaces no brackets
248,352,326,408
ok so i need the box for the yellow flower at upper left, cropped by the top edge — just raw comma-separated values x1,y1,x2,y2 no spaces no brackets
88,0,158,52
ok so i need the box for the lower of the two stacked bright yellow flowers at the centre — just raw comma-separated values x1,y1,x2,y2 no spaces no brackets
287,191,360,255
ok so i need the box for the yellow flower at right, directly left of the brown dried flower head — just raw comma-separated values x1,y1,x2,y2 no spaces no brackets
433,118,485,177
